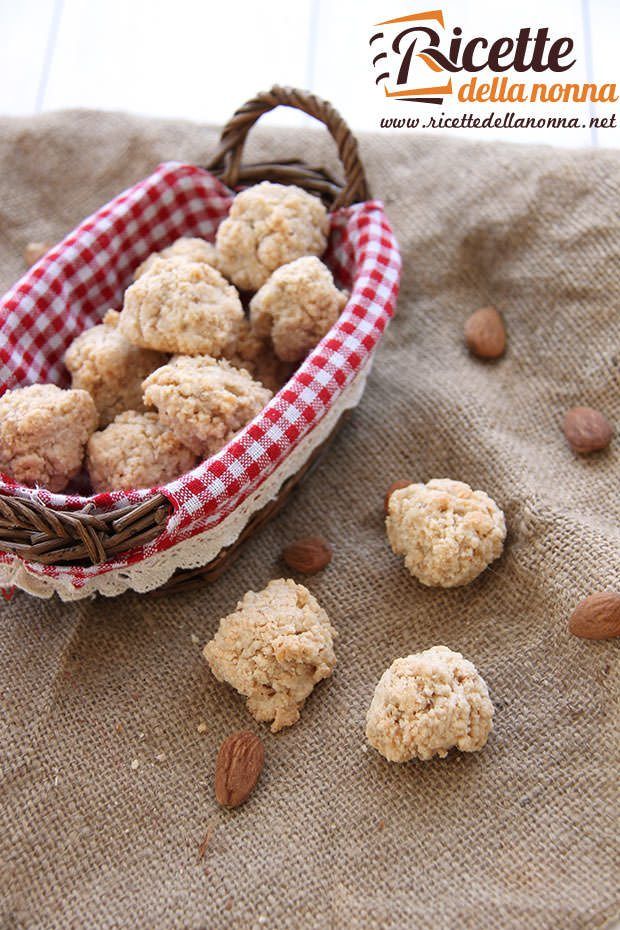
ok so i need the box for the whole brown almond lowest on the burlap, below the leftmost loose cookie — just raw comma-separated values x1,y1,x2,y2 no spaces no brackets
215,730,265,807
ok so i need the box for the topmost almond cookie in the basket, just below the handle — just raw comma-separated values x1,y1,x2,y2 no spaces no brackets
215,181,329,291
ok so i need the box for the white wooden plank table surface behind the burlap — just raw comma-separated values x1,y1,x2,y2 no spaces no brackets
0,0,620,146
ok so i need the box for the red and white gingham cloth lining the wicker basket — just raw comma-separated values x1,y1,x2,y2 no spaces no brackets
0,162,401,588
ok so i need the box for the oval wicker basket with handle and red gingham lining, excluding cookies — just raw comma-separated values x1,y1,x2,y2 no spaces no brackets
0,87,400,599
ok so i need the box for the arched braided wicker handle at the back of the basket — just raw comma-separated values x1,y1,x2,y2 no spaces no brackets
207,84,370,209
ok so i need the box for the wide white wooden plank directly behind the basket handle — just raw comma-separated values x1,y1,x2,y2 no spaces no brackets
44,0,312,123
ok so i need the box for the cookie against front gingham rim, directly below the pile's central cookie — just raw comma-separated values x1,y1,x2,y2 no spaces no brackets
143,355,272,458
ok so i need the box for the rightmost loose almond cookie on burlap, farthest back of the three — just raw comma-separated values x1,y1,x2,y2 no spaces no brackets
385,478,506,588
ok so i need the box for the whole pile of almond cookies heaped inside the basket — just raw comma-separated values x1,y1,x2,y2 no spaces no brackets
0,182,348,491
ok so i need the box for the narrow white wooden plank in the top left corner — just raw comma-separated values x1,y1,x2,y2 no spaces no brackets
0,0,54,116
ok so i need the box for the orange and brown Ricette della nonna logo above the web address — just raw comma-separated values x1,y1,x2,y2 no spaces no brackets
369,10,619,105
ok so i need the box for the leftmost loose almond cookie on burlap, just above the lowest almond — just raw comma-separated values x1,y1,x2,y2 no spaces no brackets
204,579,337,733
